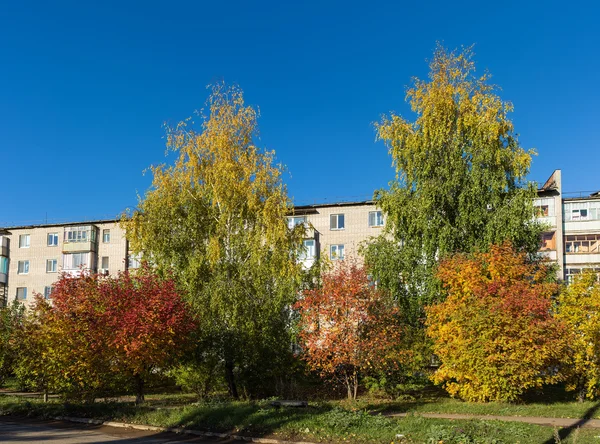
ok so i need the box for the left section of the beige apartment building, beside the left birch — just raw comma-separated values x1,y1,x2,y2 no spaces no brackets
0,220,130,304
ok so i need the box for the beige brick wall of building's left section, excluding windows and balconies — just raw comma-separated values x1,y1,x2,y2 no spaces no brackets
7,221,127,304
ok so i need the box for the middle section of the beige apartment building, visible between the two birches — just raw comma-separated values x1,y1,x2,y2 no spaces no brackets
288,201,384,267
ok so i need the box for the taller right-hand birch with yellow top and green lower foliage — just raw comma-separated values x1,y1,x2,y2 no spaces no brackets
365,47,541,325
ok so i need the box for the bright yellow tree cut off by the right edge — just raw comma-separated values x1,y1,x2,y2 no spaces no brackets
558,271,600,401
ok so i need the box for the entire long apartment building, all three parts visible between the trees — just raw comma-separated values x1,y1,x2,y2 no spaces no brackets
0,170,600,306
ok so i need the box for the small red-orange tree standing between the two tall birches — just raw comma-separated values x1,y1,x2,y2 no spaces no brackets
295,261,402,399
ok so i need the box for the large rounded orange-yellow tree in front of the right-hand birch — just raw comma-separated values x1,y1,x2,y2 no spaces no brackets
427,243,567,401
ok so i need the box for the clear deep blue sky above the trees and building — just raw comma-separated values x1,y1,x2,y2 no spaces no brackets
0,0,600,226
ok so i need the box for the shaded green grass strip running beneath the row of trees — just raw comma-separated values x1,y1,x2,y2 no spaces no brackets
0,396,600,444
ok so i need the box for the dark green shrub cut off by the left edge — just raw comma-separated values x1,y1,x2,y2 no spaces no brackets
0,300,25,387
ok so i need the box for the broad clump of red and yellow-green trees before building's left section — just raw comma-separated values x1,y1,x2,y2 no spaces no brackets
20,267,195,403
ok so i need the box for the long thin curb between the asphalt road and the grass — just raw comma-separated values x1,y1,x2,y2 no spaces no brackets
53,416,316,444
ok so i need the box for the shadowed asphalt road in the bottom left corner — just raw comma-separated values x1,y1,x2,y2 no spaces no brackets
0,416,240,444
